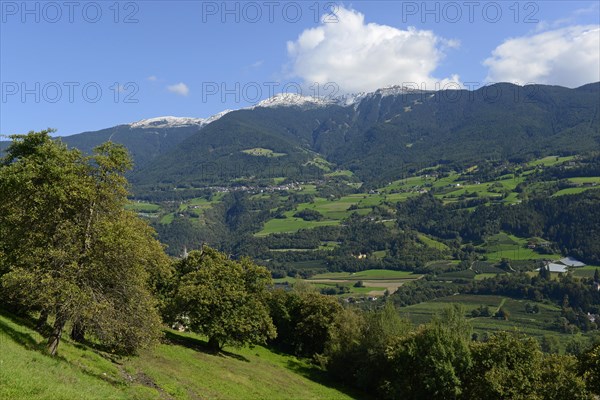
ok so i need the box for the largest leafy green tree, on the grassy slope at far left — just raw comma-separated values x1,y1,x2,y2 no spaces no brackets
0,130,167,355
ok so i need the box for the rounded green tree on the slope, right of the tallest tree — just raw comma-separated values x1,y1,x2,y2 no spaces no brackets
171,246,276,351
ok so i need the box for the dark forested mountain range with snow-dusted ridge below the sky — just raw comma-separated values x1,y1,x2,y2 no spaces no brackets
2,83,600,189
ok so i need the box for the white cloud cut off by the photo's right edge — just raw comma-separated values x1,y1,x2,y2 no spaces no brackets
483,25,600,87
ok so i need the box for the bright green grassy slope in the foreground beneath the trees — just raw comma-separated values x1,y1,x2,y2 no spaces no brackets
0,313,360,400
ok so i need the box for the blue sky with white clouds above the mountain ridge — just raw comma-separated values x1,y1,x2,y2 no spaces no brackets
0,0,600,135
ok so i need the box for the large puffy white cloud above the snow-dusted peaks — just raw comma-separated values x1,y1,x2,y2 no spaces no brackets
287,7,458,92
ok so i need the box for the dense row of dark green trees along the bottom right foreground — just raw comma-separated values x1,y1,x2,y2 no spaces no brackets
271,289,600,399
